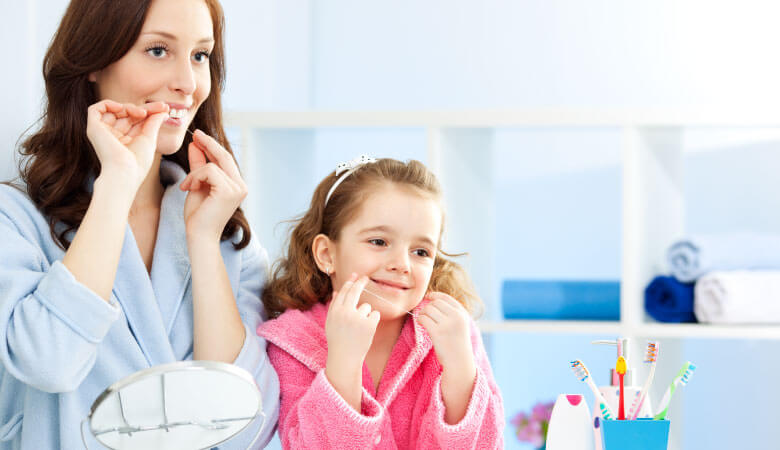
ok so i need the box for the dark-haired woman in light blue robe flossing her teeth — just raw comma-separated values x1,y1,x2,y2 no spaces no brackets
0,0,279,449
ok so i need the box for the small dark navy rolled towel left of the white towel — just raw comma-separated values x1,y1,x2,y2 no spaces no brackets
645,277,696,323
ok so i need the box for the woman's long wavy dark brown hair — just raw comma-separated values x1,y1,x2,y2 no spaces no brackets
14,0,251,249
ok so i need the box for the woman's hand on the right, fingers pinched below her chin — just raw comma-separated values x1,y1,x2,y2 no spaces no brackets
180,130,248,242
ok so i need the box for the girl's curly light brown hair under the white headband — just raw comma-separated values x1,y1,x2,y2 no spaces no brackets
263,158,481,317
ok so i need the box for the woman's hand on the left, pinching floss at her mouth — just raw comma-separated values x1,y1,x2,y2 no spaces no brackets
87,100,169,189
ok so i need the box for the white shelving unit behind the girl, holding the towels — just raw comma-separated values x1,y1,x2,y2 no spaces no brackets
225,109,780,339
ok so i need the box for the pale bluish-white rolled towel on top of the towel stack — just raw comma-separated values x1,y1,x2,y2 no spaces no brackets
666,233,780,283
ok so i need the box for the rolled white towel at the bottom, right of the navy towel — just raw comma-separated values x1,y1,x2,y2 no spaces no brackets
693,270,780,324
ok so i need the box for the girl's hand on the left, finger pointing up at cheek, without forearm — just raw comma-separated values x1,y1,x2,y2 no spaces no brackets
325,274,379,372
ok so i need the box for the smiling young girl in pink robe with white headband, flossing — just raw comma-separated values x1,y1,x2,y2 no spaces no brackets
258,157,504,449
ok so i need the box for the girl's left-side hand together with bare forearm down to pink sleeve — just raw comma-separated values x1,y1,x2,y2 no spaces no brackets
325,274,379,412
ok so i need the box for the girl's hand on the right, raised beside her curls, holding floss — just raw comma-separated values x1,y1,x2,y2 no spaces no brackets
417,292,475,372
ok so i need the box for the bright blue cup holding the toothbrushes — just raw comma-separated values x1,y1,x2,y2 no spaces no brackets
601,418,669,450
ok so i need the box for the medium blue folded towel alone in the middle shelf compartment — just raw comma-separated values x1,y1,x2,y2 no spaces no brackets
501,280,620,320
